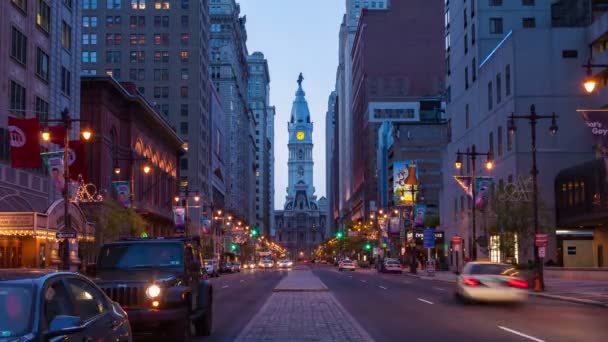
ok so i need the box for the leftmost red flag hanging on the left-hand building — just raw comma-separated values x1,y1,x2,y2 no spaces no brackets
8,117,42,169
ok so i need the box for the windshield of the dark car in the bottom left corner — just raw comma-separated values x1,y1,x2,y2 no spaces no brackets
0,283,34,338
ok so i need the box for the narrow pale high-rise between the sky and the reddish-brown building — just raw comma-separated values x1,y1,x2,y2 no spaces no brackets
336,0,391,230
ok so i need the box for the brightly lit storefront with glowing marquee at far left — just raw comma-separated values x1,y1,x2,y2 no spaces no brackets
0,200,94,270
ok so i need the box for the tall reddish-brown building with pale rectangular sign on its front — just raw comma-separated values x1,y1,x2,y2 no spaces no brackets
350,1,444,222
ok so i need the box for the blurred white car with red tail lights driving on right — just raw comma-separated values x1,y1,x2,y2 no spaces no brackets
455,262,528,302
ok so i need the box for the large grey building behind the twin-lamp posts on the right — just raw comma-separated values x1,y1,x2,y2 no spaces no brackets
441,1,605,264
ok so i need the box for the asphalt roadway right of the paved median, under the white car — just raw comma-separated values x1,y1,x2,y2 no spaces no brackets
313,266,608,341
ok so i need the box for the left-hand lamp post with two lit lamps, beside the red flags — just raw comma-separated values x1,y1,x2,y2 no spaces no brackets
41,108,92,270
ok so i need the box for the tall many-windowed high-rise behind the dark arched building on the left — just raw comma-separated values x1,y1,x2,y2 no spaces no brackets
79,0,211,229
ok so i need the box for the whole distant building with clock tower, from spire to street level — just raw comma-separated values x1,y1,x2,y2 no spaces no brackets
275,74,327,260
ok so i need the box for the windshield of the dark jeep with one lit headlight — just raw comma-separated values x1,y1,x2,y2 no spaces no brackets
97,243,183,269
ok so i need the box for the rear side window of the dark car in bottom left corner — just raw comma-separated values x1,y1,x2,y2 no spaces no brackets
66,278,107,321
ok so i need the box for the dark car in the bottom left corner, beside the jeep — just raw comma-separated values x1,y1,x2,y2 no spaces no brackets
0,269,132,341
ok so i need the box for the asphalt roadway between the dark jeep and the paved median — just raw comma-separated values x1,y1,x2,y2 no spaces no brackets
196,270,287,342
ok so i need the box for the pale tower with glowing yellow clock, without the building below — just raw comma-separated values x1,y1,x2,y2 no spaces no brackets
287,74,315,198
